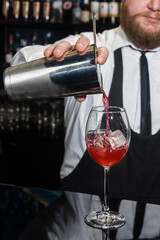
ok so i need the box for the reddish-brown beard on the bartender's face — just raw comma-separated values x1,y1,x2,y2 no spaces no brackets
120,4,160,50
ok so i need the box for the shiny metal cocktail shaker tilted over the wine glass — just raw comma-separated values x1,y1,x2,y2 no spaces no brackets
3,44,102,100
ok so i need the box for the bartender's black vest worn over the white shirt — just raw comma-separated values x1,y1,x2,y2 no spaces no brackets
62,49,160,204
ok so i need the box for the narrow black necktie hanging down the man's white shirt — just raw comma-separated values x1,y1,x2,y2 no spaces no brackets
140,52,151,135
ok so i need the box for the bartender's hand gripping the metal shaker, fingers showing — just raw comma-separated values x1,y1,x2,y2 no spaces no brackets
44,37,109,102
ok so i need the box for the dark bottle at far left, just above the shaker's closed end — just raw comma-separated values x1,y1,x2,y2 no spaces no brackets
5,34,14,68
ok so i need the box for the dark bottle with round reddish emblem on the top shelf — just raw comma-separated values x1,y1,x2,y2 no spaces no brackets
63,0,73,23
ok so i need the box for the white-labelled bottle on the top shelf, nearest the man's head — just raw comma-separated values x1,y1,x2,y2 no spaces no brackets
108,0,119,26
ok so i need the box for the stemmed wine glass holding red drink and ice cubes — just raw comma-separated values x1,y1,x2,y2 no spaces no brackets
85,106,131,229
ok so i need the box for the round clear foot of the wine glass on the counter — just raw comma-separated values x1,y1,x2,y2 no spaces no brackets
85,211,126,230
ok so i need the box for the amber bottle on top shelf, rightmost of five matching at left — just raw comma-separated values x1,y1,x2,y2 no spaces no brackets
42,0,52,22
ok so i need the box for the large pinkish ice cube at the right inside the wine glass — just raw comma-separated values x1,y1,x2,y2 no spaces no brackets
108,130,127,149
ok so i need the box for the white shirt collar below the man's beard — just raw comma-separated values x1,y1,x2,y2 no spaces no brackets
111,26,160,52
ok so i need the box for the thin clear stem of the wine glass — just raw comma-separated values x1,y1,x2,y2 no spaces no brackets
102,167,110,212
